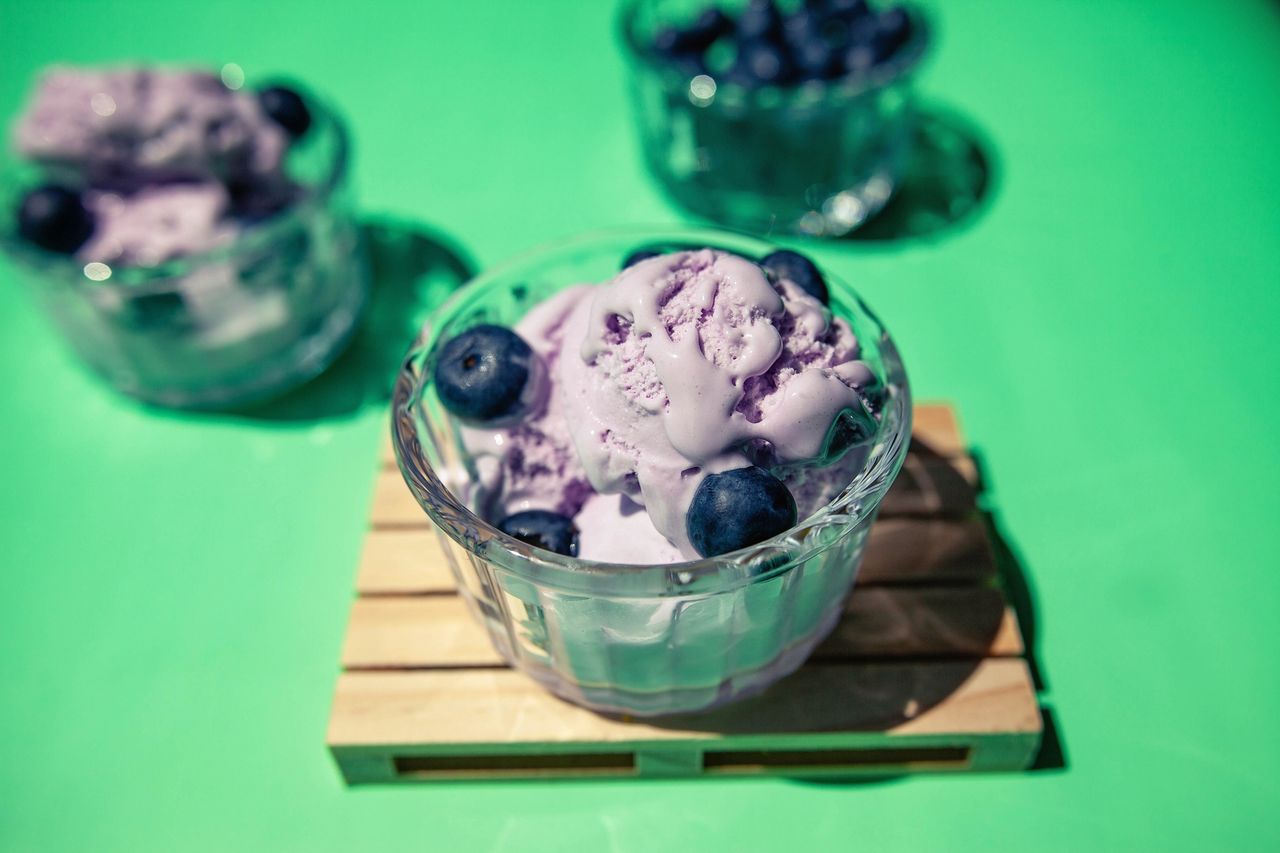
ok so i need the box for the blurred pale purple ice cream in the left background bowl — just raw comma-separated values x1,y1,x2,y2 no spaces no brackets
12,67,297,265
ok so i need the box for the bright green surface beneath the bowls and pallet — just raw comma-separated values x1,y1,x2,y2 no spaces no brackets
0,0,1280,852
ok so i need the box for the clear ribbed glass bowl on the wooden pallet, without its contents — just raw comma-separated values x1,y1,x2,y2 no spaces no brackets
392,229,911,716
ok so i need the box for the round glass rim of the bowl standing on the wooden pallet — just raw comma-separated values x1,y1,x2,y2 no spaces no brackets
390,225,911,596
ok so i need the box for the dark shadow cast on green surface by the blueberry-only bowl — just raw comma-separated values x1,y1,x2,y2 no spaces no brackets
845,106,998,243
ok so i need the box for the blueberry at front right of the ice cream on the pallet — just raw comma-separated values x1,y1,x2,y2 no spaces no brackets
685,465,796,557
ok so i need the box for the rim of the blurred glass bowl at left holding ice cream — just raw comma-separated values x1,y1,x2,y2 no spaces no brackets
0,73,352,288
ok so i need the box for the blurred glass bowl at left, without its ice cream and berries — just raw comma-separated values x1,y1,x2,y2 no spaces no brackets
0,82,369,409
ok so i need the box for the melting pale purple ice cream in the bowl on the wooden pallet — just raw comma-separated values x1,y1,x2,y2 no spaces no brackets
462,248,876,564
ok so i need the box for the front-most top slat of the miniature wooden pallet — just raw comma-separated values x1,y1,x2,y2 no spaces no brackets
329,658,1039,752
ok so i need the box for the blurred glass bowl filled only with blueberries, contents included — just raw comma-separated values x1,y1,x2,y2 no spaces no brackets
620,0,929,237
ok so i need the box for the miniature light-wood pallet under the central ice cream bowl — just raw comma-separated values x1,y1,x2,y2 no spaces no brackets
328,405,1041,784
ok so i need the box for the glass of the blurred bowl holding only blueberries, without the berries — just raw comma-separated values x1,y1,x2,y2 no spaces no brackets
618,0,929,237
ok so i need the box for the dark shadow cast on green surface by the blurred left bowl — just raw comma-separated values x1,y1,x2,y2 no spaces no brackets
227,216,476,421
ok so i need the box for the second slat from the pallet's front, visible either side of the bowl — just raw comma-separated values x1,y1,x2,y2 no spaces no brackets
342,587,1023,670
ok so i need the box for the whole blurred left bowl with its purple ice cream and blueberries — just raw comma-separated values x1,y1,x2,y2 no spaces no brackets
0,67,369,409
